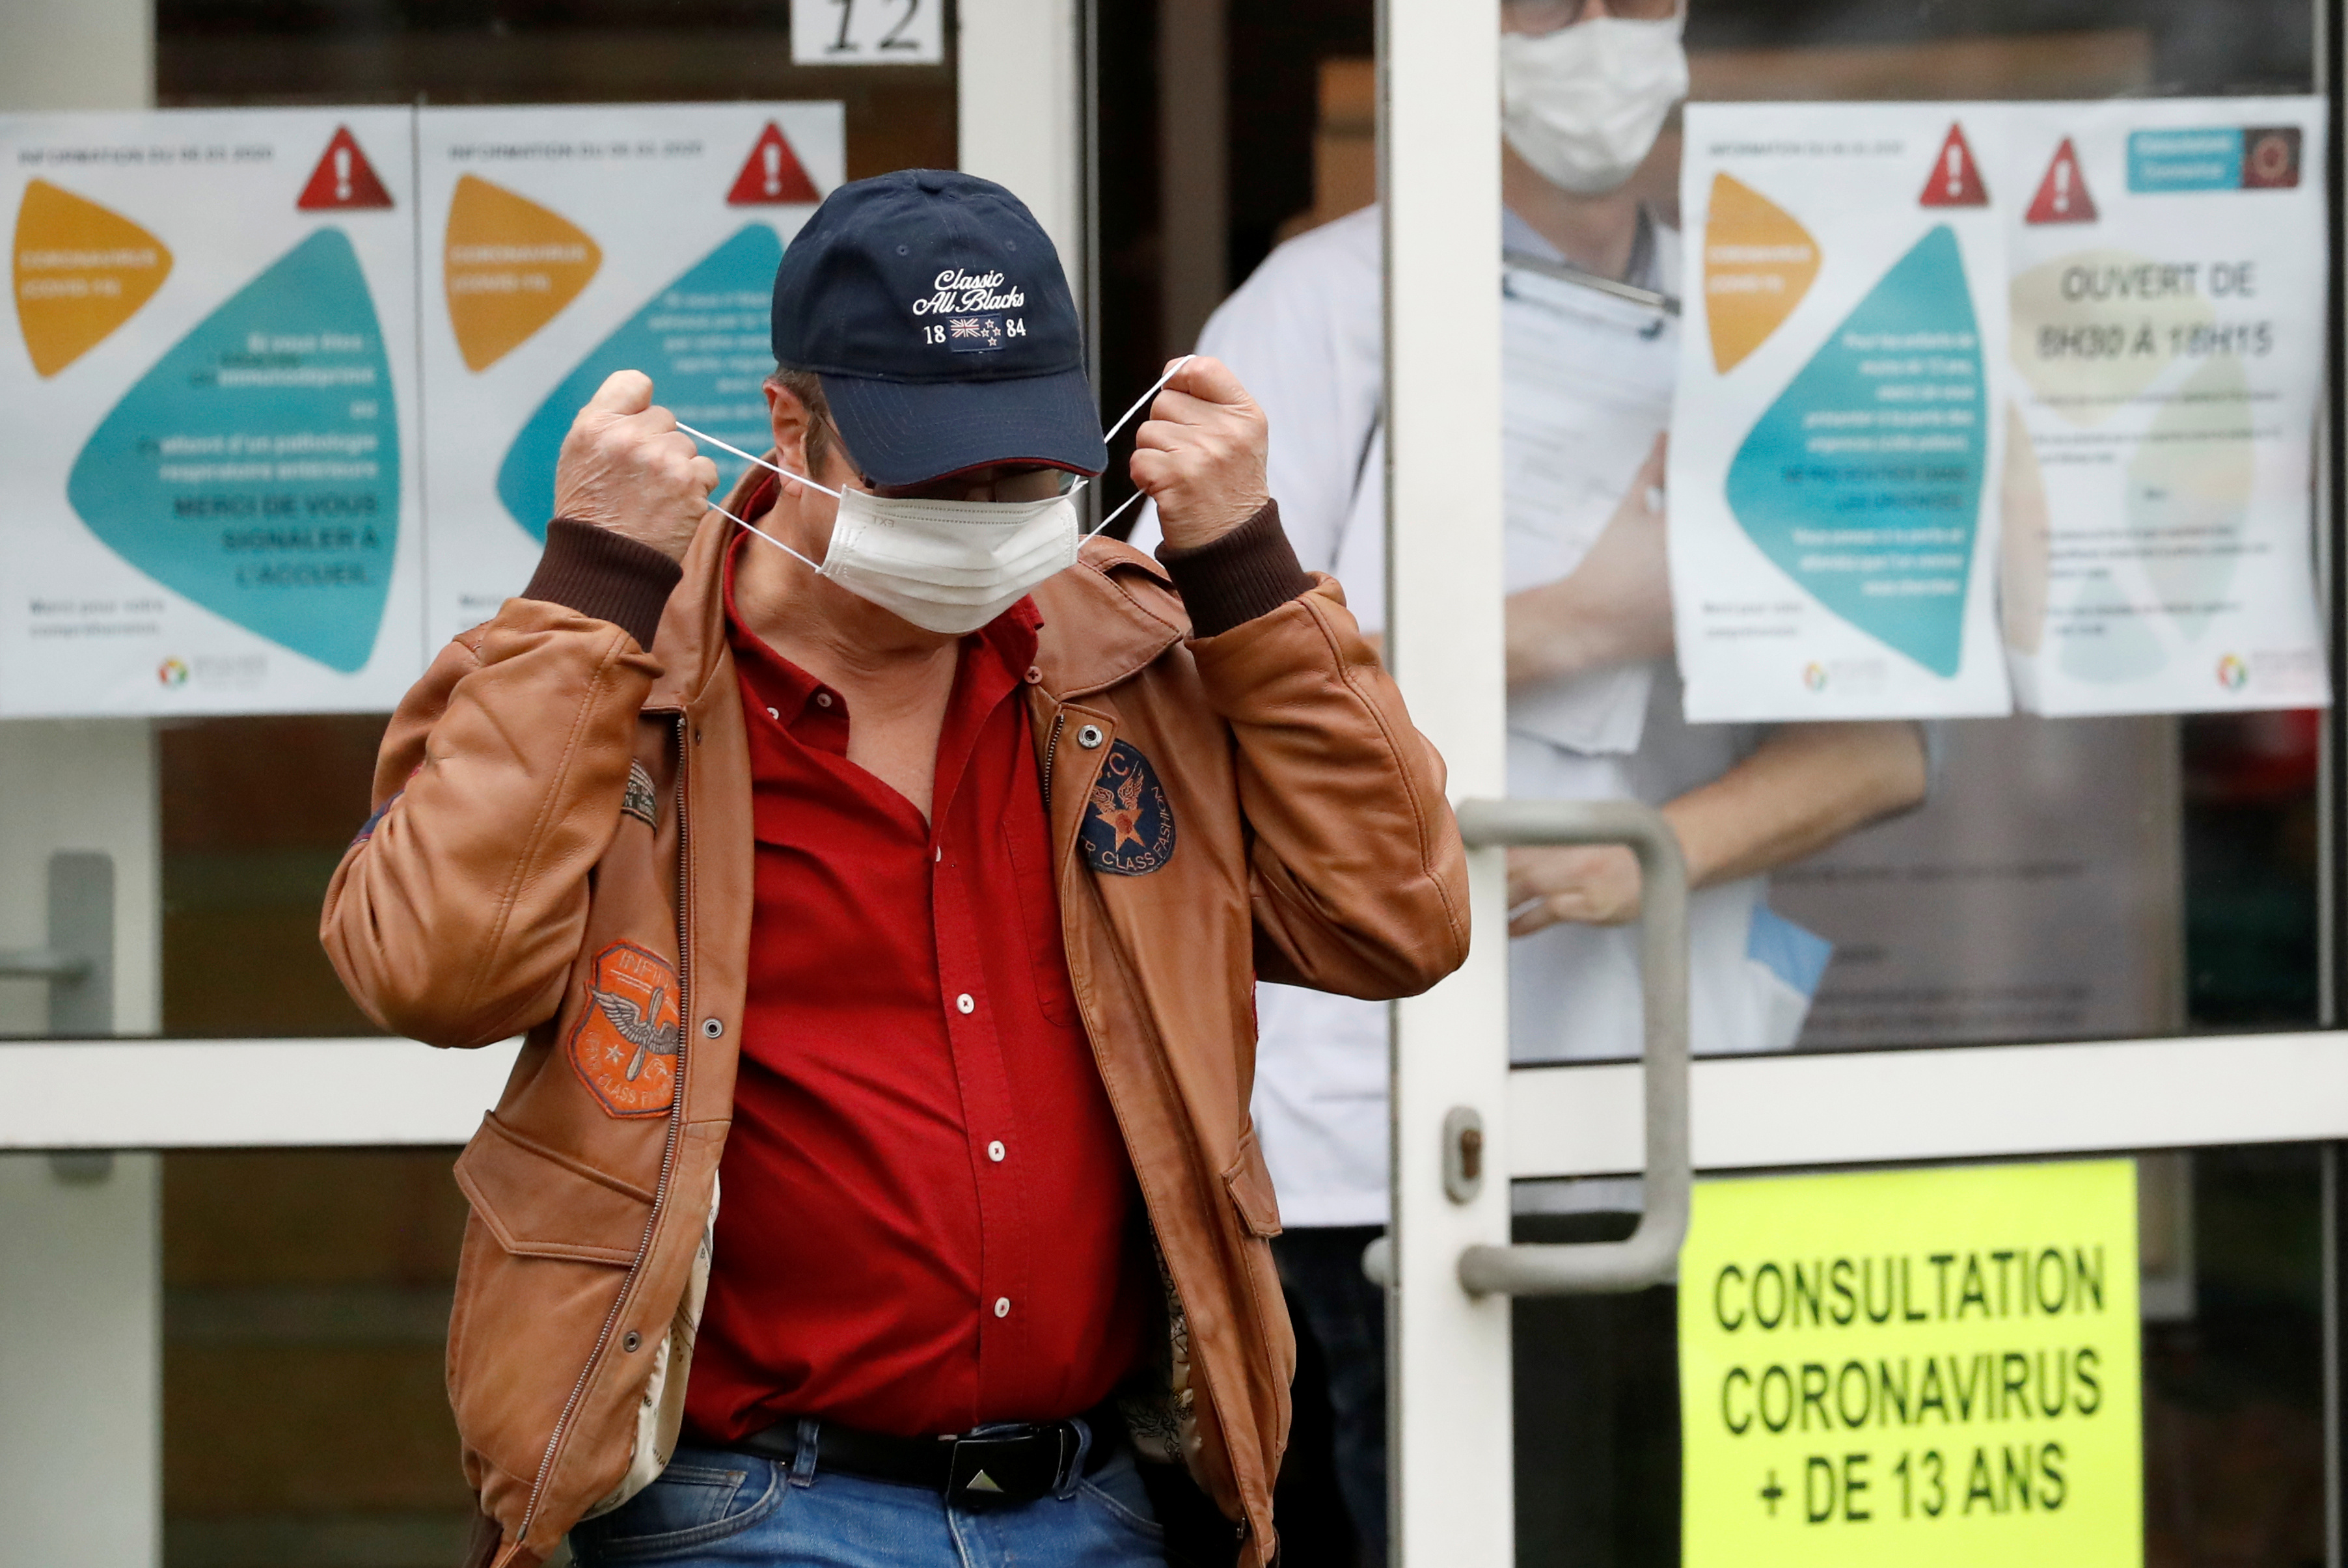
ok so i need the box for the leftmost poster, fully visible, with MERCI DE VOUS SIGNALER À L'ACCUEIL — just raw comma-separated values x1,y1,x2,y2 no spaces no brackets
0,108,422,716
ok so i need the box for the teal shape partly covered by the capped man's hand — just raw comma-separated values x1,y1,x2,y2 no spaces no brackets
498,223,782,545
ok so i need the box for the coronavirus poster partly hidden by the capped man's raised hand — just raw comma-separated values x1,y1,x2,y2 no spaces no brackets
416,103,845,645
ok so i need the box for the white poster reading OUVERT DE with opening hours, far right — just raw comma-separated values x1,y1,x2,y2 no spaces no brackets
2000,99,2329,714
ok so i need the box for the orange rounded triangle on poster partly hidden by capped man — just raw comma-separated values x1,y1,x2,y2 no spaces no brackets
441,174,603,371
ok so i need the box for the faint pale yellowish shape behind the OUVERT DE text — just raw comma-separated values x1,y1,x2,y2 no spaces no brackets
2012,251,2217,429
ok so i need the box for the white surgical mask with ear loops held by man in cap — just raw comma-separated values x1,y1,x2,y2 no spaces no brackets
679,355,1190,636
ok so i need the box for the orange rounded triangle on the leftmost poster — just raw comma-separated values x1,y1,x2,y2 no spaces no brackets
16,181,171,375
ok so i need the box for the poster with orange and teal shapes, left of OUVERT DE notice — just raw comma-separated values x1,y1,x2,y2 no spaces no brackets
1669,103,2010,721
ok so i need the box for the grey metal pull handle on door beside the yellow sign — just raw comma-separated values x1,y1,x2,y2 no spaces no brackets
1458,800,1693,1295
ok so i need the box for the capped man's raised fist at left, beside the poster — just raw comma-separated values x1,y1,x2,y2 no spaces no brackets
554,371,718,561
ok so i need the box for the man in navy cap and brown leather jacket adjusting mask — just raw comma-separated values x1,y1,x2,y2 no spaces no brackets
324,171,1468,1568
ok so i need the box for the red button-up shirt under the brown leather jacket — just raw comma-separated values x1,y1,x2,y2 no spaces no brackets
686,530,1151,1441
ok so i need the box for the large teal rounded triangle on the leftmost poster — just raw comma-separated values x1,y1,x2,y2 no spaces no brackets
66,228,399,673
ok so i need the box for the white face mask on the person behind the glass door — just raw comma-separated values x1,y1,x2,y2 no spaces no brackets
1501,9,1688,195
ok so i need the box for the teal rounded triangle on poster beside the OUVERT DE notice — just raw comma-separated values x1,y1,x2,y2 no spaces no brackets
1728,225,1989,676
